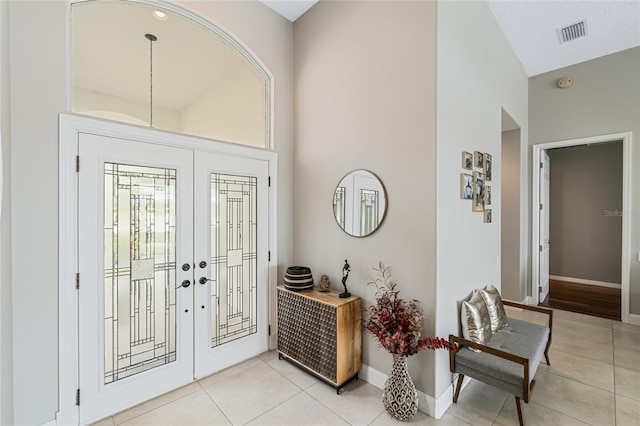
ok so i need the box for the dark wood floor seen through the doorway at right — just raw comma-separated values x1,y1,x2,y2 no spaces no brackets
542,280,621,321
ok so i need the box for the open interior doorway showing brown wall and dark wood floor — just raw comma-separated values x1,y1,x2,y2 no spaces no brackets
540,141,622,320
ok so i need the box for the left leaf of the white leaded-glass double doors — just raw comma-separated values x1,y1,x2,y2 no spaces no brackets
78,134,194,423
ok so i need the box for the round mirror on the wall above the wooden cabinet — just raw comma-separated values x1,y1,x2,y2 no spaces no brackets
333,170,387,237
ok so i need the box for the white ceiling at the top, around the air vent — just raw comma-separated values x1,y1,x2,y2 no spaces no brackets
261,0,640,76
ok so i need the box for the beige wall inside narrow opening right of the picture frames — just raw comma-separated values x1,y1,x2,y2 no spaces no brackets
500,129,527,301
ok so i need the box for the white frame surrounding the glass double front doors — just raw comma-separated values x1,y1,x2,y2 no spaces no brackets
56,113,278,425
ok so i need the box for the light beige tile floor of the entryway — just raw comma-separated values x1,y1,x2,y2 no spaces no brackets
96,309,640,426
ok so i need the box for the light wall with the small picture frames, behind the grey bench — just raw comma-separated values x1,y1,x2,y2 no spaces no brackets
436,1,528,405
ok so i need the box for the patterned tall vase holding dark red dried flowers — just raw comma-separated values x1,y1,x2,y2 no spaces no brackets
364,262,451,421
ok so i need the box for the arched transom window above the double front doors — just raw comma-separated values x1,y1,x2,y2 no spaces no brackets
71,0,271,148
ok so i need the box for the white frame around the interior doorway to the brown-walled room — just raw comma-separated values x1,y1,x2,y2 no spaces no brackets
531,132,636,323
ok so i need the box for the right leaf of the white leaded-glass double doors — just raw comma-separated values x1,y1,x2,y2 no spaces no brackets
195,152,268,377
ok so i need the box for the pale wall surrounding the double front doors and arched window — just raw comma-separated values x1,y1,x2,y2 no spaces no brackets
2,1,293,424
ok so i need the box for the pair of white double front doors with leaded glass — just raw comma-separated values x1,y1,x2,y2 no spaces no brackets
78,133,269,424
